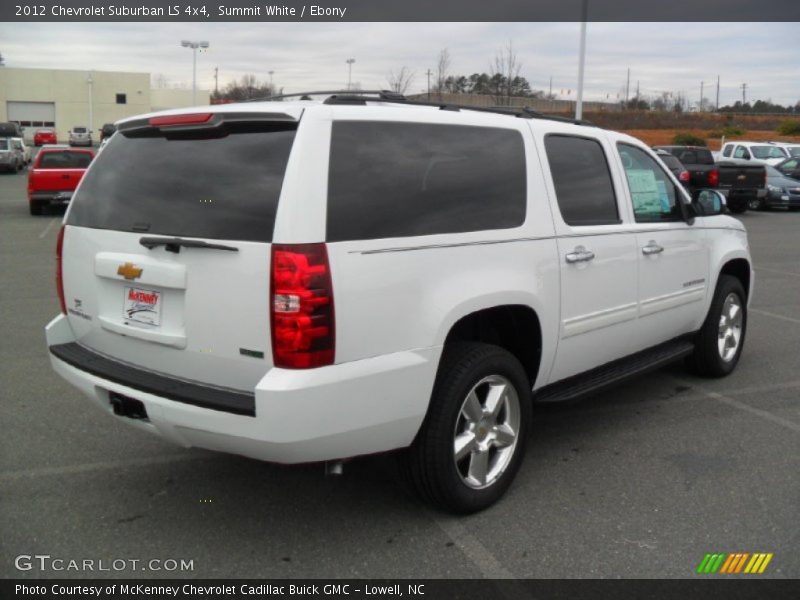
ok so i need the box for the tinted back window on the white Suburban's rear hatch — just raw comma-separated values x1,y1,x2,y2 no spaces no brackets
67,123,297,242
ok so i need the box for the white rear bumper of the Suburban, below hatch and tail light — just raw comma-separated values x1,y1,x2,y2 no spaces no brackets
46,315,441,463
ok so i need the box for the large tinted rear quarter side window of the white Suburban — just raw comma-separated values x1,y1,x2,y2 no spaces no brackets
327,121,526,242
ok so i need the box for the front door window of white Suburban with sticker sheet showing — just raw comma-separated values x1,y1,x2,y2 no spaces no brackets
617,144,683,223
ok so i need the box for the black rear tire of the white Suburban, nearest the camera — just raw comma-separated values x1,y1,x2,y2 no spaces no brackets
402,342,531,514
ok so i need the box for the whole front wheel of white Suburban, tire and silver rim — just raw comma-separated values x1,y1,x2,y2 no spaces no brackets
688,275,747,377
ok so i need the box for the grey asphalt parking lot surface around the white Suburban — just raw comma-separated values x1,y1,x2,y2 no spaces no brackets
0,161,800,578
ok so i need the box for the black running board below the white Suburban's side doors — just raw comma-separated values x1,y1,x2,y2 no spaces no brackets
533,337,694,402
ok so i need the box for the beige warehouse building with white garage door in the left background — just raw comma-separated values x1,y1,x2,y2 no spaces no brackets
0,67,210,141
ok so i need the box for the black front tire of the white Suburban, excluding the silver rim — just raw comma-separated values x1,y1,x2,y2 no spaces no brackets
687,275,747,377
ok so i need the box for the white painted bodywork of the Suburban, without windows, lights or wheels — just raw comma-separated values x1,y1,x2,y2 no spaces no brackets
46,102,752,463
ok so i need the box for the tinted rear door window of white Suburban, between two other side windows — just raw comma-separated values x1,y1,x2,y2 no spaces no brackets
544,135,620,226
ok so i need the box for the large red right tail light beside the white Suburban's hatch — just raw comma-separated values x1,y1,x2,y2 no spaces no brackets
270,244,336,369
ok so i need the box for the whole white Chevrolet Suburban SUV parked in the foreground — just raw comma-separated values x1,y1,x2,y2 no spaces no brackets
47,95,753,512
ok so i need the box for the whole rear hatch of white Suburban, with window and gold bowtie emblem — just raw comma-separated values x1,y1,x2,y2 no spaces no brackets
62,113,297,391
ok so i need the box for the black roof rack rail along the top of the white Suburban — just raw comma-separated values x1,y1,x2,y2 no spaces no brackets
241,90,597,127
